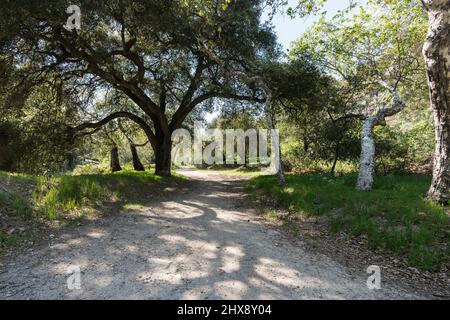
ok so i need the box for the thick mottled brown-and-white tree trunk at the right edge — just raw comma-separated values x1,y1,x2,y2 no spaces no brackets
423,0,450,204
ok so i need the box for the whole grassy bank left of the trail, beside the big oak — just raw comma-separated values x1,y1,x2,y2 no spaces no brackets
0,170,183,254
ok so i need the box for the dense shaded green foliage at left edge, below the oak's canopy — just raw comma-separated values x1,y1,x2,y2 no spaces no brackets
0,81,77,174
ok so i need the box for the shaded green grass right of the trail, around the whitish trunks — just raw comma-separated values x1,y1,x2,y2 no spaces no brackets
249,174,450,270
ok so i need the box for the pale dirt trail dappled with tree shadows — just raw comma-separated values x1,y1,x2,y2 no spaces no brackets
0,171,419,299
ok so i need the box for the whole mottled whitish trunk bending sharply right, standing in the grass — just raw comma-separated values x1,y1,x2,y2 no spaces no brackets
356,93,406,191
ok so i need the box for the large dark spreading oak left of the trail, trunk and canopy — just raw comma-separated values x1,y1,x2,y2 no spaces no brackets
1,0,277,175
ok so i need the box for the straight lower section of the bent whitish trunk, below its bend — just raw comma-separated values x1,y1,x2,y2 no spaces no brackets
356,117,378,191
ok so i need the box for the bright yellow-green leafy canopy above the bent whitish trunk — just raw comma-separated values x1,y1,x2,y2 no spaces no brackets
291,0,427,111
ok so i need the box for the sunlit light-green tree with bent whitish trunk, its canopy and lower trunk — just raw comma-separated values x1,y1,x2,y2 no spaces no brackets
293,1,425,191
